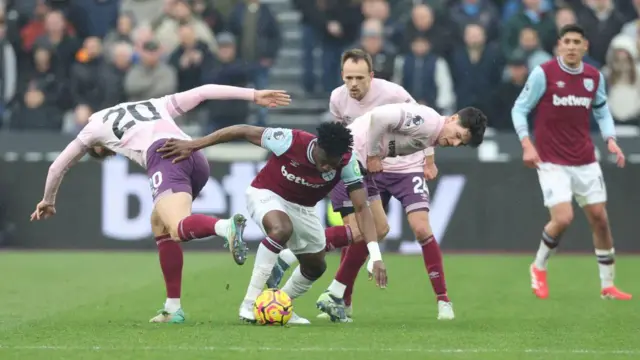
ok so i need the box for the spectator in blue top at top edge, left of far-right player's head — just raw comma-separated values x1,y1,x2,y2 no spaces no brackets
501,0,556,55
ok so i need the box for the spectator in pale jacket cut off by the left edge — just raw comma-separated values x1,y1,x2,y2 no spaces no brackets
0,9,18,120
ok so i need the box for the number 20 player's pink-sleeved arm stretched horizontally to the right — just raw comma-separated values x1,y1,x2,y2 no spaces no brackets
167,84,291,116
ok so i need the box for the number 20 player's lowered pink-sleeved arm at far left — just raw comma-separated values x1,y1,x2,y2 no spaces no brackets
31,139,88,221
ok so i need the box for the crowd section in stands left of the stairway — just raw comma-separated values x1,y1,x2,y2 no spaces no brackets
0,0,282,133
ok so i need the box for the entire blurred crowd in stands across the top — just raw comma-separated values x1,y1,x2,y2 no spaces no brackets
0,0,640,133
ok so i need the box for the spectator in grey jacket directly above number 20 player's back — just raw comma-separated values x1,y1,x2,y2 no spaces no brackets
124,40,178,101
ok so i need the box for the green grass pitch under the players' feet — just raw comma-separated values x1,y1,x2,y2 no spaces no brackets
0,252,640,360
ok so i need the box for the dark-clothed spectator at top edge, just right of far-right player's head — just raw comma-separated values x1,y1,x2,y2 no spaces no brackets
578,0,625,64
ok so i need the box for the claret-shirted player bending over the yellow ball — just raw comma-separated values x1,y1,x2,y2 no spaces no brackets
160,122,387,324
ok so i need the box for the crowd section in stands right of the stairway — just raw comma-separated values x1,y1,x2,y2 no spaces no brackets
294,0,640,131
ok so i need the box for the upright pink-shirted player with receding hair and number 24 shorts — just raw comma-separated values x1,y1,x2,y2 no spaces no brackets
267,49,454,319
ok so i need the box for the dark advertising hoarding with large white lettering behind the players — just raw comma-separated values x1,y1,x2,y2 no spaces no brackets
0,158,640,253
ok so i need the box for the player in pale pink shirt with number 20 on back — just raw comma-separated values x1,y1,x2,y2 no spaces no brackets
31,85,290,323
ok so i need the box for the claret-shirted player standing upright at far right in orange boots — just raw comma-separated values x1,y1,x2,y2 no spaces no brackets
511,25,631,300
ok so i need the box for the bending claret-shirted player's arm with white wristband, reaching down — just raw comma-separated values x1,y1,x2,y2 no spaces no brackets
340,154,387,289
